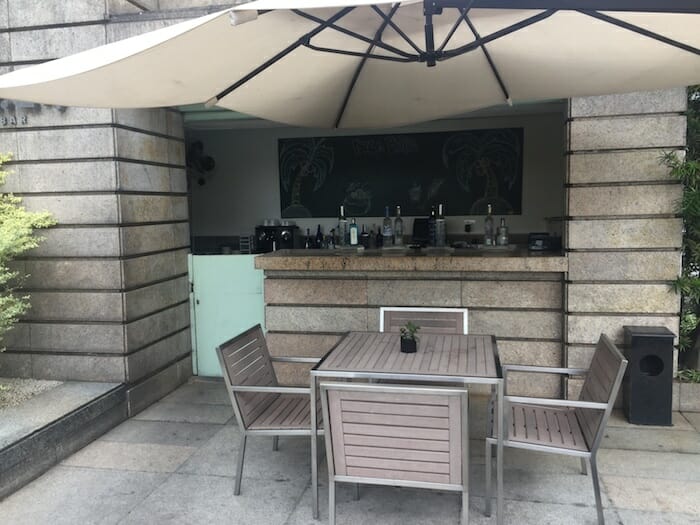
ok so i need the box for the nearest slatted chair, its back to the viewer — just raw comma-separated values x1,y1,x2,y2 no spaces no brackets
321,383,469,525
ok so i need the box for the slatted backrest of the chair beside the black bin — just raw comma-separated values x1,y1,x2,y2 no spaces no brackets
576,334,627,450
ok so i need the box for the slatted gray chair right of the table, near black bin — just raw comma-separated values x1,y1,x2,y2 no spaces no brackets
486,334,627,525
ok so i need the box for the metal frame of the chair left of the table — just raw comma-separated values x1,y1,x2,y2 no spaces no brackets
216,324,323,496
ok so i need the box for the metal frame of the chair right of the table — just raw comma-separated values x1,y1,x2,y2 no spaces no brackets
486,334,627,525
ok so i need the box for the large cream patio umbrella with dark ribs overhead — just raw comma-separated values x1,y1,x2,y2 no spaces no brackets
0,0,700,127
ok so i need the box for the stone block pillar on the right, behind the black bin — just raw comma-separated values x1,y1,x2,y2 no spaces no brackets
565,88,686,398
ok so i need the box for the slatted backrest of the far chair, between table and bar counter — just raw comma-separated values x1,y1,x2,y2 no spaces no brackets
379,307,468,334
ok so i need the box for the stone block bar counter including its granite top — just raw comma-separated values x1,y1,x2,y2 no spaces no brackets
255,250,568,395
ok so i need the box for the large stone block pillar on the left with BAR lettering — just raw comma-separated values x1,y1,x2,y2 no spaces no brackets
0,0,191,414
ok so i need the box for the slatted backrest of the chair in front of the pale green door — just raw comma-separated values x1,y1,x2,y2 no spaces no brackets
216,325,279,428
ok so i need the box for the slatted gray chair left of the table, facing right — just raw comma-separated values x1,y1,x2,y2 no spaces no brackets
216,325,323,495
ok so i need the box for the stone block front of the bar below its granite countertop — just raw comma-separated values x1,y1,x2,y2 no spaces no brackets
265,270,564,396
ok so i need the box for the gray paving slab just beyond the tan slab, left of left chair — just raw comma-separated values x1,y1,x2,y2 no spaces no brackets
100,419,223,447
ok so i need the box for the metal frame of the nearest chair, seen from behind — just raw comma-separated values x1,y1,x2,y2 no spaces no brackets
320,382,469,525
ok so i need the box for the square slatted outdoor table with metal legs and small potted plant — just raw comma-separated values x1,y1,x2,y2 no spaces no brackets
311,332,504,525
